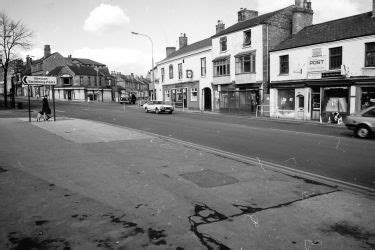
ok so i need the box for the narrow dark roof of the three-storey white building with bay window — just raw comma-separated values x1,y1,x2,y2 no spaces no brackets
212,5,294,38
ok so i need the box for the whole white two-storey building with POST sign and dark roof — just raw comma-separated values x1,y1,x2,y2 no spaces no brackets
270,2,375,122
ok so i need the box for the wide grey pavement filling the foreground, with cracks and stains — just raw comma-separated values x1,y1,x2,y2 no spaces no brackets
0,111,375,249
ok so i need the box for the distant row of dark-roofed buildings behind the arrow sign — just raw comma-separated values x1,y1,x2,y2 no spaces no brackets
0,45,150,102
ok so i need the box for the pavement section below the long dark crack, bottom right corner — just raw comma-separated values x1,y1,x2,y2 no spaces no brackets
197,192,375,249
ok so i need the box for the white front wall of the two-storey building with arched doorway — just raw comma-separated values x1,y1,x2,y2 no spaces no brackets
155,45,213,110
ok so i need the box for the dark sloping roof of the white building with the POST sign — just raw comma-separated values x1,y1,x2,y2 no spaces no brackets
272,12,375,51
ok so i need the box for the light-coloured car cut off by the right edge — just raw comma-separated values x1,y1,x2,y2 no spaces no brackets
344,106,375,138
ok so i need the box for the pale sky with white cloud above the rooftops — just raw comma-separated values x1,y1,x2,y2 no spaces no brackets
0,0,372,76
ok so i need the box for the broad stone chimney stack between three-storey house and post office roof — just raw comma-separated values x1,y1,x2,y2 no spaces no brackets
292,0,314,35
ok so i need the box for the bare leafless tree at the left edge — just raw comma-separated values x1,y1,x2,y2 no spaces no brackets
0,12,32,107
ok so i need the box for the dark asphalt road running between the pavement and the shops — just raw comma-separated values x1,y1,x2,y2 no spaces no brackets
5,98,375,188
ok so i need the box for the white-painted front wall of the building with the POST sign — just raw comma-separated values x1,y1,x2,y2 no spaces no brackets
270,35,375,121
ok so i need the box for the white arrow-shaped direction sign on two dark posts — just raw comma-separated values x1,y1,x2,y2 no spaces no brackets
22,76,57,122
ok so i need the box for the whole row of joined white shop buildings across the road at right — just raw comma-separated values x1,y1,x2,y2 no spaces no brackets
154,0,375,121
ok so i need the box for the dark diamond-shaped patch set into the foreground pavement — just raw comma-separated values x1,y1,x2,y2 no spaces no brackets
180,169,238,187
